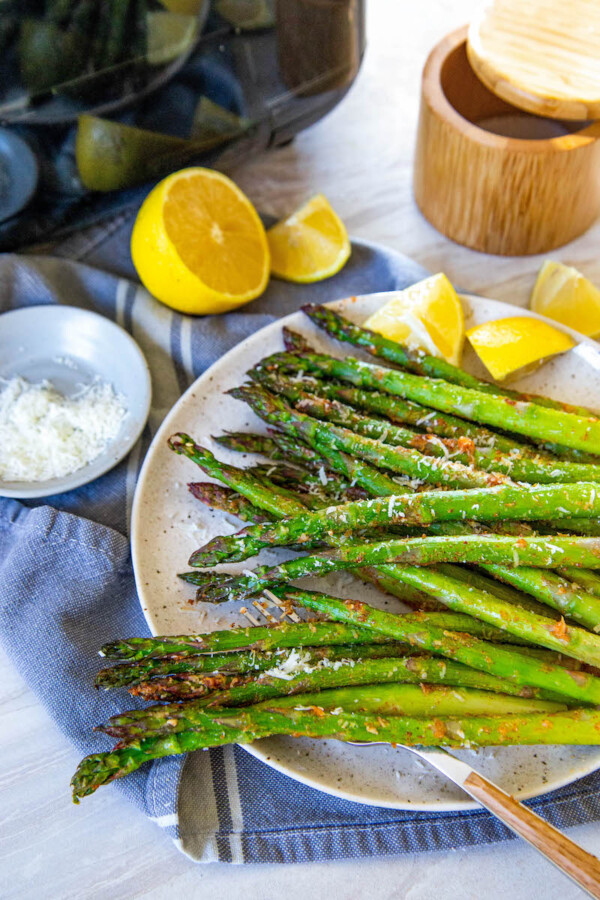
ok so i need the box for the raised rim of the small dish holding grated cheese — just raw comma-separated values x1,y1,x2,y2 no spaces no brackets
0,303,152,500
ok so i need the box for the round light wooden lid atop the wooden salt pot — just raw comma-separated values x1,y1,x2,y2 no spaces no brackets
467,0,600,120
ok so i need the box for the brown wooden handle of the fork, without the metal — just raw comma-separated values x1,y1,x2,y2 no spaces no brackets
463,772,600,900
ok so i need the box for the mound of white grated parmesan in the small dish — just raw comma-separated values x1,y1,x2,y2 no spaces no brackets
0,376,126,481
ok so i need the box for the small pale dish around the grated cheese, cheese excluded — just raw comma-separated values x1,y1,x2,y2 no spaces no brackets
0,306,151,500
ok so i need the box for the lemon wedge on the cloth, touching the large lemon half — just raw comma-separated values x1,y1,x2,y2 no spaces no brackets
267,194,351,283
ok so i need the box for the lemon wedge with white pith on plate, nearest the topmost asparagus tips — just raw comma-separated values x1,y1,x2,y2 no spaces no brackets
364,272,465,366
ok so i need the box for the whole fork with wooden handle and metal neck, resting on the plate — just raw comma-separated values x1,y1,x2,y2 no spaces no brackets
348,741,600,900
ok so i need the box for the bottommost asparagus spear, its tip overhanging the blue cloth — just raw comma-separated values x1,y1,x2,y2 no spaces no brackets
71,706,600,802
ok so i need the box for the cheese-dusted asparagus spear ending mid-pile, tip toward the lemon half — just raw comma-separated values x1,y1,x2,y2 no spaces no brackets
229,385,512,487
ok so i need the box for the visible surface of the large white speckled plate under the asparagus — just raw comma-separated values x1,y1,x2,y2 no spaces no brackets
132,294,600,812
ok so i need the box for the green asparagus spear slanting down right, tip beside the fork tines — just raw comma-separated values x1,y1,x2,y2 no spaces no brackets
273,587,600,704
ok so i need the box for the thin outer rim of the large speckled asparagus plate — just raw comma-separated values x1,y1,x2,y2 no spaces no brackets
131,291,600,813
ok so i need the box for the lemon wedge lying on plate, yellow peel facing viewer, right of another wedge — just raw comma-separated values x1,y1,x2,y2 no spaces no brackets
467,316,575,381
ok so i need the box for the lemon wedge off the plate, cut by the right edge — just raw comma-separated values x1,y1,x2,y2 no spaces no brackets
529,259,600,337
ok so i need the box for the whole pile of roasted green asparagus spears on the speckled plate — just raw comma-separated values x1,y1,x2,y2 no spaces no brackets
73,306,600,798
